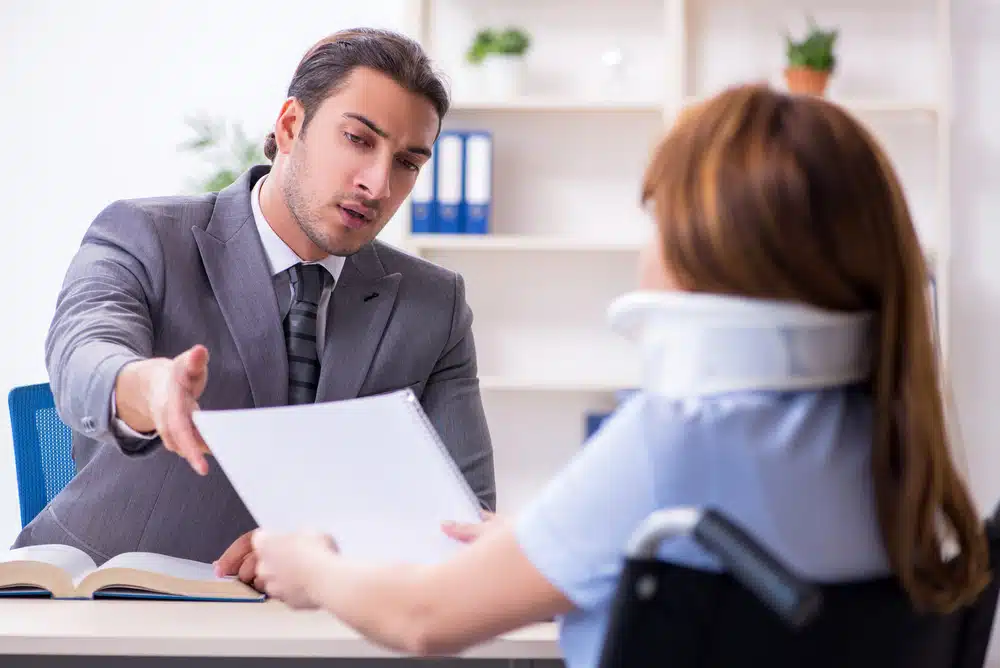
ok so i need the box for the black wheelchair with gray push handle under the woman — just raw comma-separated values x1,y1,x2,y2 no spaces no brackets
599,506,1000,668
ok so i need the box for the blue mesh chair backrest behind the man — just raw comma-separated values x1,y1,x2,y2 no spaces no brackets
7,383,76,527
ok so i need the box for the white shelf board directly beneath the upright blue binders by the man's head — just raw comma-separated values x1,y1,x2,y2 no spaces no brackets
407,234,645,253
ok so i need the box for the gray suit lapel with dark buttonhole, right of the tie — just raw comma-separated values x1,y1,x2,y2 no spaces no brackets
316,244,402,401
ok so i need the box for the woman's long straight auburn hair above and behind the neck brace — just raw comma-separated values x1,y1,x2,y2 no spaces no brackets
642,85,990,612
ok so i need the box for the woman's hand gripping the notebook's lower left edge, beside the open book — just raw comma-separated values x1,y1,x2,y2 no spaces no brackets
252,530,337,609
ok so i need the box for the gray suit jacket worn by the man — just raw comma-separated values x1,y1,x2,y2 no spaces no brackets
15,166,495,563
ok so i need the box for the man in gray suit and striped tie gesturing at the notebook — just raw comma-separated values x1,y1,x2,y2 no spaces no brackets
15,30,495,582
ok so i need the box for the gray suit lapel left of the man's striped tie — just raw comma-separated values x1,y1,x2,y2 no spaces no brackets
194,167,288,407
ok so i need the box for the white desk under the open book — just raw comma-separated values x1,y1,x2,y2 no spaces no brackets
0,599,559,667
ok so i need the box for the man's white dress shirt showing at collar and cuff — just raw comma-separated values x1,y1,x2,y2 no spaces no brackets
111,175,346,439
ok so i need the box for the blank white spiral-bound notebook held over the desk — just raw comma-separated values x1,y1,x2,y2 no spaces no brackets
194,389,481,564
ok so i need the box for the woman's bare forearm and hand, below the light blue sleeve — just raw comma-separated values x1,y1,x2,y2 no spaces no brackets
254,525,573,655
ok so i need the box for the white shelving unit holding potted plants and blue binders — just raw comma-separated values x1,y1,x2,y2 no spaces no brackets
400,0,952,512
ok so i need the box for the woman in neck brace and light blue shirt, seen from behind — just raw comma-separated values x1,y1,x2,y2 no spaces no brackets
248,86,989,668
